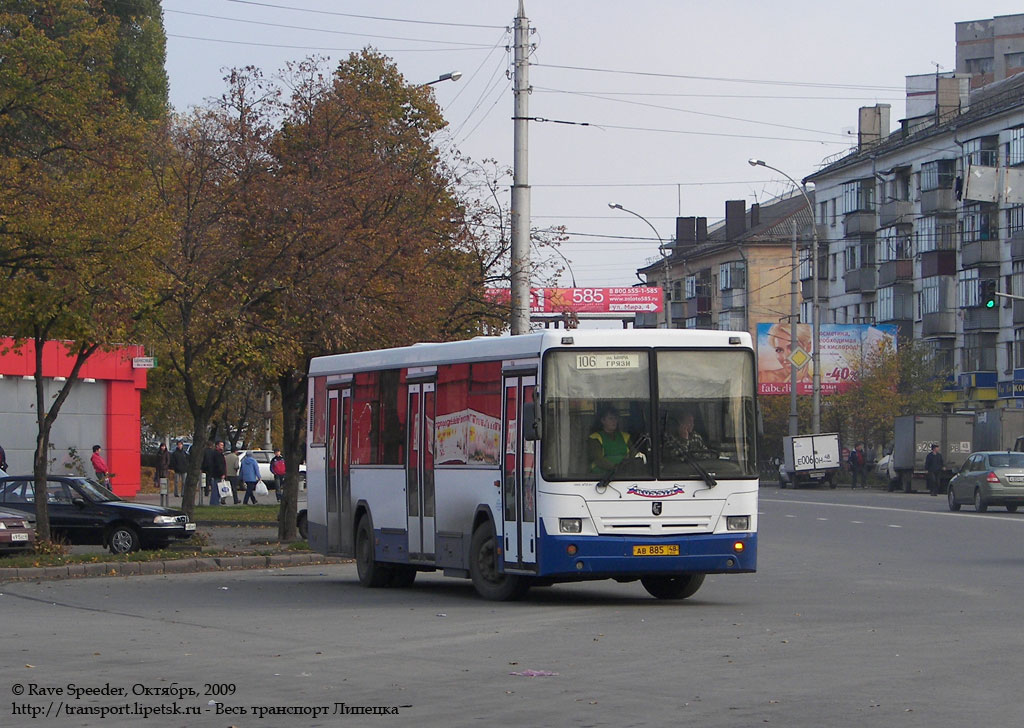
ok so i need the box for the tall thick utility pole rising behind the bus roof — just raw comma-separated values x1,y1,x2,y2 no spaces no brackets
511,0,530,336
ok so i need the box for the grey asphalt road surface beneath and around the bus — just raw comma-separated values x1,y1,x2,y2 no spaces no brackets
0,487,1024,728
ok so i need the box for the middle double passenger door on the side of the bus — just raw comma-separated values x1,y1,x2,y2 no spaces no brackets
406,382,434,561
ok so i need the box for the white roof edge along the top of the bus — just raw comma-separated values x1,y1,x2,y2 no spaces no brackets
309,329,752,377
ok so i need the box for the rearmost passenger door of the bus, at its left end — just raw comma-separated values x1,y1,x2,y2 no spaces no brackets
326,389,354,554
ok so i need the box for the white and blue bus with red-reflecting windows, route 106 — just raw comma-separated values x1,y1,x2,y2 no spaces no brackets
306,330,758,600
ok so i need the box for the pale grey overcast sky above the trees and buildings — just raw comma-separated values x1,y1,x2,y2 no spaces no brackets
163,0,1024,287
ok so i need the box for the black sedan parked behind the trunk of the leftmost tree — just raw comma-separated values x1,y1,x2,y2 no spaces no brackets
0,475,196,554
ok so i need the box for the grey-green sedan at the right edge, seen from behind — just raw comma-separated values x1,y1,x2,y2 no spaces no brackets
946,451,1024,513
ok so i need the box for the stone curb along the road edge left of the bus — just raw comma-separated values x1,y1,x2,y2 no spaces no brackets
0,554,348,584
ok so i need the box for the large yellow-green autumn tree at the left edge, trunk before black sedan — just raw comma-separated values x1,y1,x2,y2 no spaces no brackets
0,0,164,540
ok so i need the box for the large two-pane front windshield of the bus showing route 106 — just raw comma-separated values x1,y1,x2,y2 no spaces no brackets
541,349,757,480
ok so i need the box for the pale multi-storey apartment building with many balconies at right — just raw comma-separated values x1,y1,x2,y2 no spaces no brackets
804,15,1024,409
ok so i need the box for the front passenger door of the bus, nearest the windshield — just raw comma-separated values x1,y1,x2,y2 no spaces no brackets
502,376,537,570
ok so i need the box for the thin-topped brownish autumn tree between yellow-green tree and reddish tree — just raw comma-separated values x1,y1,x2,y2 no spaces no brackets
142,69,280,514
